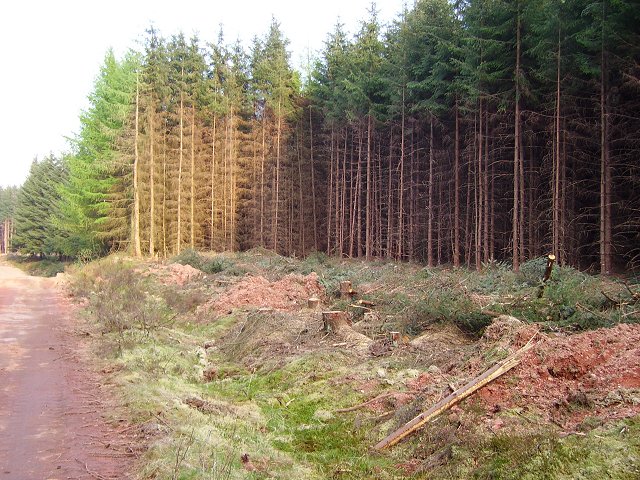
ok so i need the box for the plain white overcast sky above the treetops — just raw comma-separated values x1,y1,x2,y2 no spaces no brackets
0,0,404,186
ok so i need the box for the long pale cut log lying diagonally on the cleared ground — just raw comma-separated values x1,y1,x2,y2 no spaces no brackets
373,335,535,450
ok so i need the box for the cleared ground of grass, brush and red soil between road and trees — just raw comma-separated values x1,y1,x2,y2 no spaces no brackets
20,250,640,480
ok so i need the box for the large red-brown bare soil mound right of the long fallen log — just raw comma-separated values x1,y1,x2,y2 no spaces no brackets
479,325,640,427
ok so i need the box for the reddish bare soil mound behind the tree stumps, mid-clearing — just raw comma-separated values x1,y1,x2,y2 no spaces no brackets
204,273,324,313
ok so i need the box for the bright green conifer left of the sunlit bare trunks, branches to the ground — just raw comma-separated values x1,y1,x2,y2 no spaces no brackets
60,51,138,256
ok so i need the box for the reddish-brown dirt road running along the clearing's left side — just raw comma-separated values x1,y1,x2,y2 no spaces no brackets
0,262,132,480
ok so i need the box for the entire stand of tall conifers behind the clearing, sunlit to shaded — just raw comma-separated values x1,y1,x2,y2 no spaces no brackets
0,0,640,273
